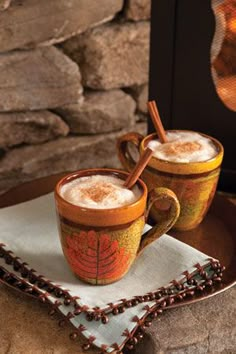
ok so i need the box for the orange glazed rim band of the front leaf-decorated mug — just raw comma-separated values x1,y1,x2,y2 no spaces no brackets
54,168,148,227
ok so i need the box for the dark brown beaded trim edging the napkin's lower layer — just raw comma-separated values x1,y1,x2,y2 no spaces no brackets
0,253,225,353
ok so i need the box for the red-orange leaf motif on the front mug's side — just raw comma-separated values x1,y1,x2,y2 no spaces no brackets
65,230,130,283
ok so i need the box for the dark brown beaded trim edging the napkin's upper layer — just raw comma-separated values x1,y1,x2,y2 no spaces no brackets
0,244,224,324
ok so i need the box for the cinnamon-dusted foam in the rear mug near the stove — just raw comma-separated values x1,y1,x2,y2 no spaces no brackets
148,131,218,162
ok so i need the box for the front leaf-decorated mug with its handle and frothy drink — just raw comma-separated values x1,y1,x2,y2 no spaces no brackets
55,169,180,285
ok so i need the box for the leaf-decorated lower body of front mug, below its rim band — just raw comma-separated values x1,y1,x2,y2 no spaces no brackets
59,216,145,285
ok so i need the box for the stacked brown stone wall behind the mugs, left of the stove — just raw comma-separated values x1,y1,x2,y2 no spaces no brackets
0,0,150,193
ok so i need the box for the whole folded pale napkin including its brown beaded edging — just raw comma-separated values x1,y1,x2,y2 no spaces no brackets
0,194,222,353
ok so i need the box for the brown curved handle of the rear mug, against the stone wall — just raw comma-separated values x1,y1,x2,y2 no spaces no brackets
117,132,144,172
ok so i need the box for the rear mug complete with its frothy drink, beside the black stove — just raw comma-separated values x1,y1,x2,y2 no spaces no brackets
117,130,224,231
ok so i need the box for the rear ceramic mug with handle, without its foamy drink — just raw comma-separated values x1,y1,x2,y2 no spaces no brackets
117,133,224,231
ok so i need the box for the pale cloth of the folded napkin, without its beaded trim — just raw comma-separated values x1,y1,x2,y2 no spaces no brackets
0,194,217,353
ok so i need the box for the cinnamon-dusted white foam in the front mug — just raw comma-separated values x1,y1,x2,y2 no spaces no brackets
60,175,141,209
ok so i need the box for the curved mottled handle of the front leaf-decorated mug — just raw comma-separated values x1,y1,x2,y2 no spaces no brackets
137,187,180,255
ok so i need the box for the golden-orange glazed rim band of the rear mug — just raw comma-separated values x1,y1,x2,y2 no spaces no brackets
140,129,224,175
